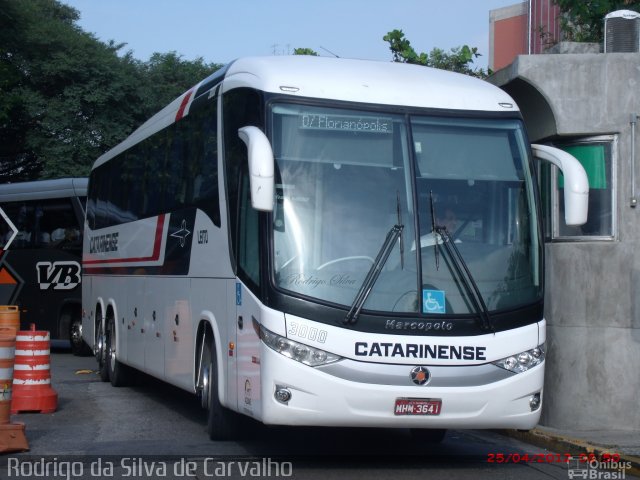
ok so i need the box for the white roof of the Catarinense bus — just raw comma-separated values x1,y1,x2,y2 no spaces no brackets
94,55,518,168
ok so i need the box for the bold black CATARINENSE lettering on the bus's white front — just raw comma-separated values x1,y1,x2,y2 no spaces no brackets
355,342,487,360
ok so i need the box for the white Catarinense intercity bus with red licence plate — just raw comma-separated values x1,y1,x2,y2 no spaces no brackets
82,56,588,440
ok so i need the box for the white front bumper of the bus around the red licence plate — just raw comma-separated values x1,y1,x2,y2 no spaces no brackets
254,345,544,429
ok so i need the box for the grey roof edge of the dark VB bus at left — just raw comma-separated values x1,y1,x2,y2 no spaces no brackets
0,178,88,202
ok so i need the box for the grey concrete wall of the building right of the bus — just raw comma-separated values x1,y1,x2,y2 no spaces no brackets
490,53,640,431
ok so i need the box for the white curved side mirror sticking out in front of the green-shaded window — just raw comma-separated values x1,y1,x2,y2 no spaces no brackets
531,145,589,226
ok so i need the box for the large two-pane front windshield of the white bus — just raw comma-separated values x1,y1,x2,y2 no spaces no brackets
272,103,542,315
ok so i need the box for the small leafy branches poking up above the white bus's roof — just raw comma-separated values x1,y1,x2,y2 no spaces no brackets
382,30,488,78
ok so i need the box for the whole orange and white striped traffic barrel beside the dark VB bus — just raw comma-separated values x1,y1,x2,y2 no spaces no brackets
11,324,58,414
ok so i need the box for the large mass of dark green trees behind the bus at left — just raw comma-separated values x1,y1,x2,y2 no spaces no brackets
0,0,219,182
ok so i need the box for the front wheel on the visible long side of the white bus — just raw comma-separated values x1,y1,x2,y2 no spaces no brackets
201,336,239,440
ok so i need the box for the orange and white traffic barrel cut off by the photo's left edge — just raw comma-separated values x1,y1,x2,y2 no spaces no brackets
0,327,29,453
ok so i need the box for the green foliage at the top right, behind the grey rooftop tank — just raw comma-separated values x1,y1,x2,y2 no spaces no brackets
554,0,640,43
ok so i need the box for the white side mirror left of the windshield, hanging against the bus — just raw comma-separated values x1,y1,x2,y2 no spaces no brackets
238,127,274,212
